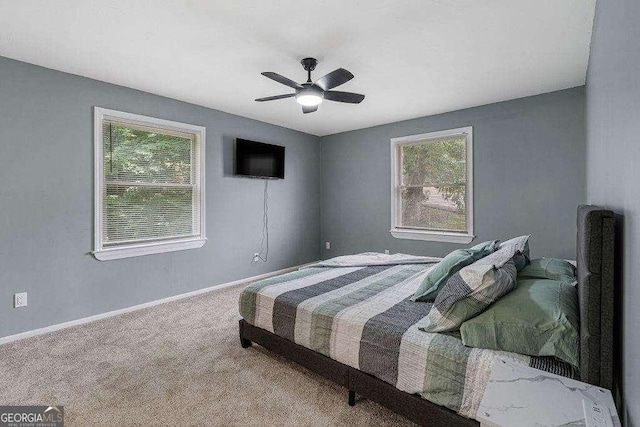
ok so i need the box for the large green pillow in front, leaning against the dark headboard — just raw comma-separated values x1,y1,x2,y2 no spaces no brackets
460,279,579,367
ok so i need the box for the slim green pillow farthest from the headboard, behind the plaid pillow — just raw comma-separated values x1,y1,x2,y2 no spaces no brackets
411,240,498,302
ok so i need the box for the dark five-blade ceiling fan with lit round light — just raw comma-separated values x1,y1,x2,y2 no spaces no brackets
256,58,364,114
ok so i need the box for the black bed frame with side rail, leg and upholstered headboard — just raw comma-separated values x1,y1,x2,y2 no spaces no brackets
240,206,615,426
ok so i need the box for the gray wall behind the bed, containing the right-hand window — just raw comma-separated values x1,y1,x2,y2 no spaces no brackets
321,87,585,259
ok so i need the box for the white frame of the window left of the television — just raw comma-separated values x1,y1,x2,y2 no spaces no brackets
92,107,207,261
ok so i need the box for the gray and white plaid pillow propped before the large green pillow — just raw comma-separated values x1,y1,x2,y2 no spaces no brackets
418,245,518,332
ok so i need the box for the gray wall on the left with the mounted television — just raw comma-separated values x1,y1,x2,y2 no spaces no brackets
0,57,320,337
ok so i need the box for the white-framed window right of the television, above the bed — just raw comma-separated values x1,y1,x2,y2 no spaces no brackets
391,127,474,243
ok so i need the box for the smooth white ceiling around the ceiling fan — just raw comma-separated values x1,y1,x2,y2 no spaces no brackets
0,0,595,135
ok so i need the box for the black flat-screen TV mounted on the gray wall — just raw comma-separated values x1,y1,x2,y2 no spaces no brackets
235,138,284,179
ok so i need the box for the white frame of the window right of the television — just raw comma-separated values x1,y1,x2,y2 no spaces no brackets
389,126,475,243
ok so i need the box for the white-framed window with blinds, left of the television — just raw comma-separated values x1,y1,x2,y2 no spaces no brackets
93,107,206,261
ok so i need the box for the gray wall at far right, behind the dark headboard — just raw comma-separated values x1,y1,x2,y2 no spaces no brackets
586,0,640,426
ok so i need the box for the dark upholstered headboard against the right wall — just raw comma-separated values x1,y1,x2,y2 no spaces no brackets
576,205,615,389
